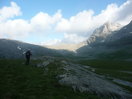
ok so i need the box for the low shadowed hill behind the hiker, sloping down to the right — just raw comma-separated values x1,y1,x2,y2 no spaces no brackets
0,39,61,58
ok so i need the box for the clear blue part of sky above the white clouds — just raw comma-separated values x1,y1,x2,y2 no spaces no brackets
0,0,126,19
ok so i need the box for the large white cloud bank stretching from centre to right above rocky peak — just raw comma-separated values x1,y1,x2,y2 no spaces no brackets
56,0,132,37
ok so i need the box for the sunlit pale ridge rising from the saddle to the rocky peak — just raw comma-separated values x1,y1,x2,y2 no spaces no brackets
46,22,122,52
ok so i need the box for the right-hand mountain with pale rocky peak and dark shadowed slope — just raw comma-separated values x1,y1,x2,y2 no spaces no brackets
77,21,132,59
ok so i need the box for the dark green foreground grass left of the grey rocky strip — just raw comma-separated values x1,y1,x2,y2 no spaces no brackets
0,59,99,99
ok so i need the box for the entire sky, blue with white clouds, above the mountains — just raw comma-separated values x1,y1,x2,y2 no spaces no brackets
0,0,132,45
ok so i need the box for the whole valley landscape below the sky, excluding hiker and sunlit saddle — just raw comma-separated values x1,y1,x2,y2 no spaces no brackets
0,22,132,99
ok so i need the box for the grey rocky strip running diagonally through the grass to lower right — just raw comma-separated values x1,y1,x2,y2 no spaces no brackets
35,58,132,99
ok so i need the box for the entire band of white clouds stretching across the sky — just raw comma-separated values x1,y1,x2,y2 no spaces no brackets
0,0,132,45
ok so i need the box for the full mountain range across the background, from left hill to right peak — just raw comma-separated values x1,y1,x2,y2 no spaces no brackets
0,21,132,59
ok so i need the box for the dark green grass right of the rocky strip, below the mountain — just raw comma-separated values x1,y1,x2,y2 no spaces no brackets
79,60,132,82
